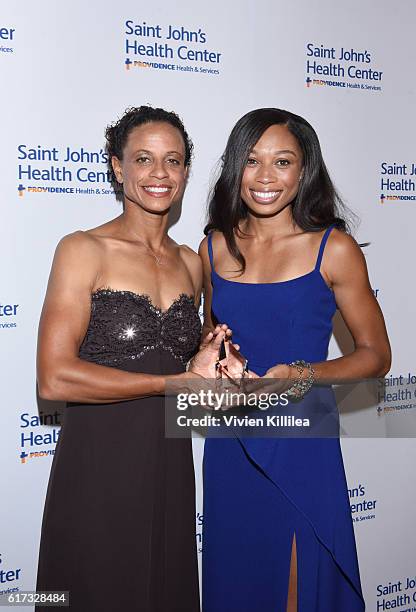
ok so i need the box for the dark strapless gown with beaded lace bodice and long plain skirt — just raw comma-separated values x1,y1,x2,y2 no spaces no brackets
36,289,201,612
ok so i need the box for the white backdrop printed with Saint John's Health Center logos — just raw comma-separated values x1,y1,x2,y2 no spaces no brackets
0,0,416,611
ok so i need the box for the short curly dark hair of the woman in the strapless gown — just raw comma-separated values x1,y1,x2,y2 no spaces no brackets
105,105,194,183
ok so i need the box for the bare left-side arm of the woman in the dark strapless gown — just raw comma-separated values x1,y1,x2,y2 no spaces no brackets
37,232,224,403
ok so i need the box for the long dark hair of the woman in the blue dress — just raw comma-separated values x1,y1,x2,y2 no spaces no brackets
204,108,352,273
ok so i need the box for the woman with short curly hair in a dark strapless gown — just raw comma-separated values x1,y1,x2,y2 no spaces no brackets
37,107,224,612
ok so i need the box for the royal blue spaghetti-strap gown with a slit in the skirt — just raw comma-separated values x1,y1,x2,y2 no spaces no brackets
202,227,365,612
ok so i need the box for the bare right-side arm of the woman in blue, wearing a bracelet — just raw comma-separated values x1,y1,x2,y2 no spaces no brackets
266,230,391,380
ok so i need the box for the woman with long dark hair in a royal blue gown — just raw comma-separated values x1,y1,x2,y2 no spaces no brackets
200,109,390,612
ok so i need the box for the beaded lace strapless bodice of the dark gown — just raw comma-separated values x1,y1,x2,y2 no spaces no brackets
79,289,201,367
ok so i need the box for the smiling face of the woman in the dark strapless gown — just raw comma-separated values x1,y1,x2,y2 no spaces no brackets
111,122,187,214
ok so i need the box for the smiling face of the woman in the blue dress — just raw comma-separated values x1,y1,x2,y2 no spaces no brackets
241,124,303,217
